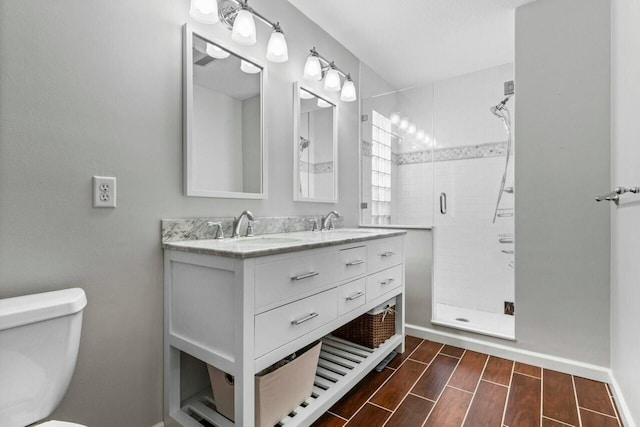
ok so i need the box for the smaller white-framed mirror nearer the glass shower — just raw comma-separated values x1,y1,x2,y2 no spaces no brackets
293,83,338,203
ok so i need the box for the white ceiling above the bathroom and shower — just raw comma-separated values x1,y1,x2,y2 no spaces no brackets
289,0,534,89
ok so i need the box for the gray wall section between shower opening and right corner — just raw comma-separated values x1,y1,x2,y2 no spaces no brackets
515,0,611,366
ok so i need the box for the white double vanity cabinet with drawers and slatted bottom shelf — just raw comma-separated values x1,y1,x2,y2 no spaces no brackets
164,231,404,427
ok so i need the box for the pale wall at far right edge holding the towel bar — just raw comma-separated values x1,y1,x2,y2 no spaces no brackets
605,0,640,426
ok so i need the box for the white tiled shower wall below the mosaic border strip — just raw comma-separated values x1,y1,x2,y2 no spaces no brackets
434,156,514,313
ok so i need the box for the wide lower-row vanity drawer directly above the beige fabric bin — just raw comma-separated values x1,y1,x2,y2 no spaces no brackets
255,288,338,358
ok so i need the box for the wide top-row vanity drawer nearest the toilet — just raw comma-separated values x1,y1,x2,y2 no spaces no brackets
255,251,337,308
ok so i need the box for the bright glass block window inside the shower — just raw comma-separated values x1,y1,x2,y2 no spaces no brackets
371,110,395,224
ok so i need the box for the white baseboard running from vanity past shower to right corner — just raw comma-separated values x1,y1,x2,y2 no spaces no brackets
405,324,612,383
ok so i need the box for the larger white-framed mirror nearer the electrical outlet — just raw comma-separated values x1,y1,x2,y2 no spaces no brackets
183,24,267,199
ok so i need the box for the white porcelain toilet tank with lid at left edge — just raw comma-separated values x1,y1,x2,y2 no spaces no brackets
0,288,87,427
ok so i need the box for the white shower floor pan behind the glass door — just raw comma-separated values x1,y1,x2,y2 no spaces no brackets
431,304,516,341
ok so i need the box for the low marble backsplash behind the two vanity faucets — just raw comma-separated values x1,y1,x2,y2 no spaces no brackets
162,215,344,243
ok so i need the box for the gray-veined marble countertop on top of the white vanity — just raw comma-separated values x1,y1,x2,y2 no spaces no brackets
162,228,406,258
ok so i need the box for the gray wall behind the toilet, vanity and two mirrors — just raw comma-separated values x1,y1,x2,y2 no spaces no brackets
0,0,359,427
